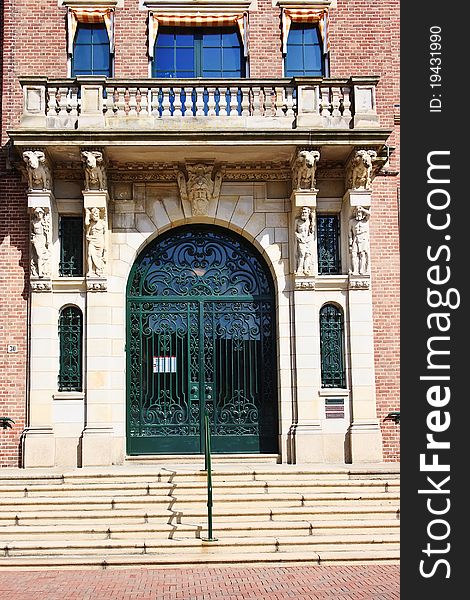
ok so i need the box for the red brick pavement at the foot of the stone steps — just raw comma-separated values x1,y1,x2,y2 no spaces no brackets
0,565,400,600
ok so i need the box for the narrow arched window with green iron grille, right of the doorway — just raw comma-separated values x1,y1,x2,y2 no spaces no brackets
320,304,346,388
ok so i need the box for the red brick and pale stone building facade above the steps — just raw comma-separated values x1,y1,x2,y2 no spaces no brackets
0,0,399,466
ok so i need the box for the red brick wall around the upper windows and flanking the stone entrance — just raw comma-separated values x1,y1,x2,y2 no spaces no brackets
0,0,399,464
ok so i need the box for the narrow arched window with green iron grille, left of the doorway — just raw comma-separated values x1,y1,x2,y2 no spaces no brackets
58,306,83,392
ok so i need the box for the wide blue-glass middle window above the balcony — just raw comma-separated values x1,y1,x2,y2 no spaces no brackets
152,27,245,79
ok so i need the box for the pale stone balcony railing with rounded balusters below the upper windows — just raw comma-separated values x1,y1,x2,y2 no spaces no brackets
20,76,378,130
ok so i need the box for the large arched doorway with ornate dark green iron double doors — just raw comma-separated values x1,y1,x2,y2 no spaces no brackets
127,225,278,454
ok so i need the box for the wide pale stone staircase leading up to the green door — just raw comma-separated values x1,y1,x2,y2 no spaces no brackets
0,463,399,570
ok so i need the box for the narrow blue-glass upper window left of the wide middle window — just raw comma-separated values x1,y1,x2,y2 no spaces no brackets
72,23,111,77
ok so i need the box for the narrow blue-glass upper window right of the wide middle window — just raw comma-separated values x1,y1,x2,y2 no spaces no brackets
284,23,325,77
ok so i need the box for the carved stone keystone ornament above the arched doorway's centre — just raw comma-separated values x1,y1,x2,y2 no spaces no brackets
177,164,223,216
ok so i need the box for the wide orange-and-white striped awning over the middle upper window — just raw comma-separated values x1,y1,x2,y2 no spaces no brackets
148,13,248,58
